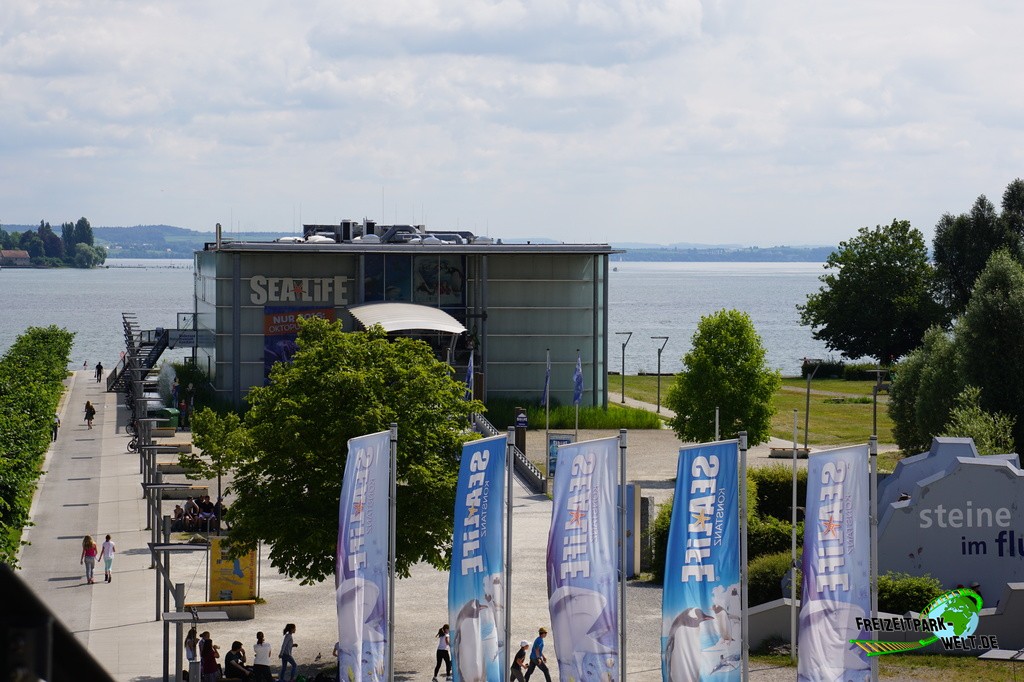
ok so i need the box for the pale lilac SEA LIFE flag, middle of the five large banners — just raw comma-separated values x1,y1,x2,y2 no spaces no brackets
548,437,621,680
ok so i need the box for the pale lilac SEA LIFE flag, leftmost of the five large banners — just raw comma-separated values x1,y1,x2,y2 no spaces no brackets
335,431,391,682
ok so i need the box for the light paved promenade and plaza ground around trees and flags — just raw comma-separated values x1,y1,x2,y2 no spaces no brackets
20,371,892,682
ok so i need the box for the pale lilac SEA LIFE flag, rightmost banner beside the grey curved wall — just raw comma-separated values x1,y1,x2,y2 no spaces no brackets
798,445,871,682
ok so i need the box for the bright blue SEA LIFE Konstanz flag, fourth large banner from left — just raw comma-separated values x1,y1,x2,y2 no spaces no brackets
662,440,743,682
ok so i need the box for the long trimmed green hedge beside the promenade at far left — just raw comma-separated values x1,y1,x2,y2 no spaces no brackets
0,326,75,565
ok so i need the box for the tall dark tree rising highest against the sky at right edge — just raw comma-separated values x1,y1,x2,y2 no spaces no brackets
932,193,1021,316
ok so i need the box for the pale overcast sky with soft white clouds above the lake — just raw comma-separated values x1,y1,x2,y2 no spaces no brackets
0,0,1024,246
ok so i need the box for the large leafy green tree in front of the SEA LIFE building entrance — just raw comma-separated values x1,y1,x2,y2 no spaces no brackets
228,319,483,584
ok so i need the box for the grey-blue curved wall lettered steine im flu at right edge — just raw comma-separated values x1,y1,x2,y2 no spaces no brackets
879,438,1024,593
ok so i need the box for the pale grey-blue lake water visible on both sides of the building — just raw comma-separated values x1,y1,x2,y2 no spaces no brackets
0,259,827,374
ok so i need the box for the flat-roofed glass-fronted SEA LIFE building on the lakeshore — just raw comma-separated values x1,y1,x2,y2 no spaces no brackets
195,220,613,406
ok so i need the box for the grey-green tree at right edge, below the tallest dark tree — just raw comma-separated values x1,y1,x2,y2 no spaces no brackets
956,251,1024,450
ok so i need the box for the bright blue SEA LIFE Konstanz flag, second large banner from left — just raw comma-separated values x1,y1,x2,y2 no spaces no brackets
449,434,508,682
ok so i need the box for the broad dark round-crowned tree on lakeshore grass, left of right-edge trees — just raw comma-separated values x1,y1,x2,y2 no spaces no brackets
797,220,944,364
